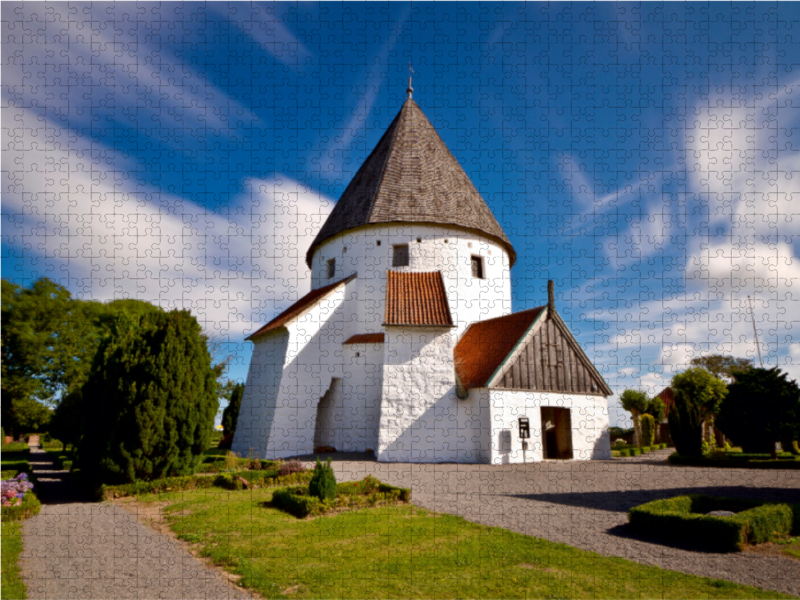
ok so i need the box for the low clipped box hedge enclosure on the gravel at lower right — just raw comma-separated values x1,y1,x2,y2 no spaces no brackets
628,494,800,552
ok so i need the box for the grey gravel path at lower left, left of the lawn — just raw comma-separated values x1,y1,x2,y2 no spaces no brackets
20,448,255,600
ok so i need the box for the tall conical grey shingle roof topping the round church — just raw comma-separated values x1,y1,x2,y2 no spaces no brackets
306,98,516,266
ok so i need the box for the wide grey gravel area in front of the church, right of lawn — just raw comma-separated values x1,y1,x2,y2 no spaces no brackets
302,449,800,596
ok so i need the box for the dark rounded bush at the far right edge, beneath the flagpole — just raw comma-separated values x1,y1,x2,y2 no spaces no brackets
716,367,800,452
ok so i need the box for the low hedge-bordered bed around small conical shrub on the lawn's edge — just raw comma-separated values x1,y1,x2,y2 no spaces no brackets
272,475,411,519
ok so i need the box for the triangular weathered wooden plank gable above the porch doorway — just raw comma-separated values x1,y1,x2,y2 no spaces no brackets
489,310,612,396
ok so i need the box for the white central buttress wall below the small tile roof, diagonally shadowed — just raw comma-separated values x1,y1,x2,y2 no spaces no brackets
377,327,489,463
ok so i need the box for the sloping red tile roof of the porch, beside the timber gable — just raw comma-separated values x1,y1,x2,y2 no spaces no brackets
453,306,547,389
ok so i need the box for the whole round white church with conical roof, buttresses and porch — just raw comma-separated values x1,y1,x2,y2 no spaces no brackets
233,93,612,464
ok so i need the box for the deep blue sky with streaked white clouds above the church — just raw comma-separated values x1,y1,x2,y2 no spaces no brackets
2,2,800,421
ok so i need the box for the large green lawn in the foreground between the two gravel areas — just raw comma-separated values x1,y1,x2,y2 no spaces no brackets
126,488,788,598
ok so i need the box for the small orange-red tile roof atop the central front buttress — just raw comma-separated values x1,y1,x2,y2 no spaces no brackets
385,271,453,327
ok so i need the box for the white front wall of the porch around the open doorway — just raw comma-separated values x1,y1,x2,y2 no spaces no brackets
484,389,611,464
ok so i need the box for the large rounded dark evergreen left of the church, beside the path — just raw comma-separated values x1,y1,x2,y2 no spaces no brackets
78,310,218,482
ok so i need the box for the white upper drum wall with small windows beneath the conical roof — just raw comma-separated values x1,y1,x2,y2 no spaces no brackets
311,224,511,337
